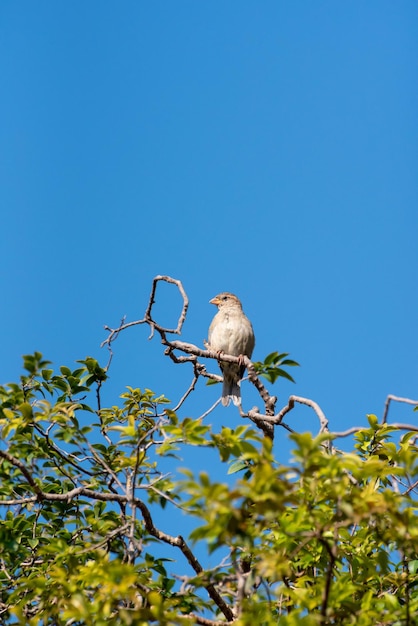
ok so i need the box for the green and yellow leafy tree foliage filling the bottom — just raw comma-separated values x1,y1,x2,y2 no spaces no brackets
0,353,418,626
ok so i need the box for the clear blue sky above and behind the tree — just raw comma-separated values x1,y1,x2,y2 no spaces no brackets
0,0,418,460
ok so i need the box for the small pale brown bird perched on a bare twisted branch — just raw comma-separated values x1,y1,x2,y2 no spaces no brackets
208,292,255,406
